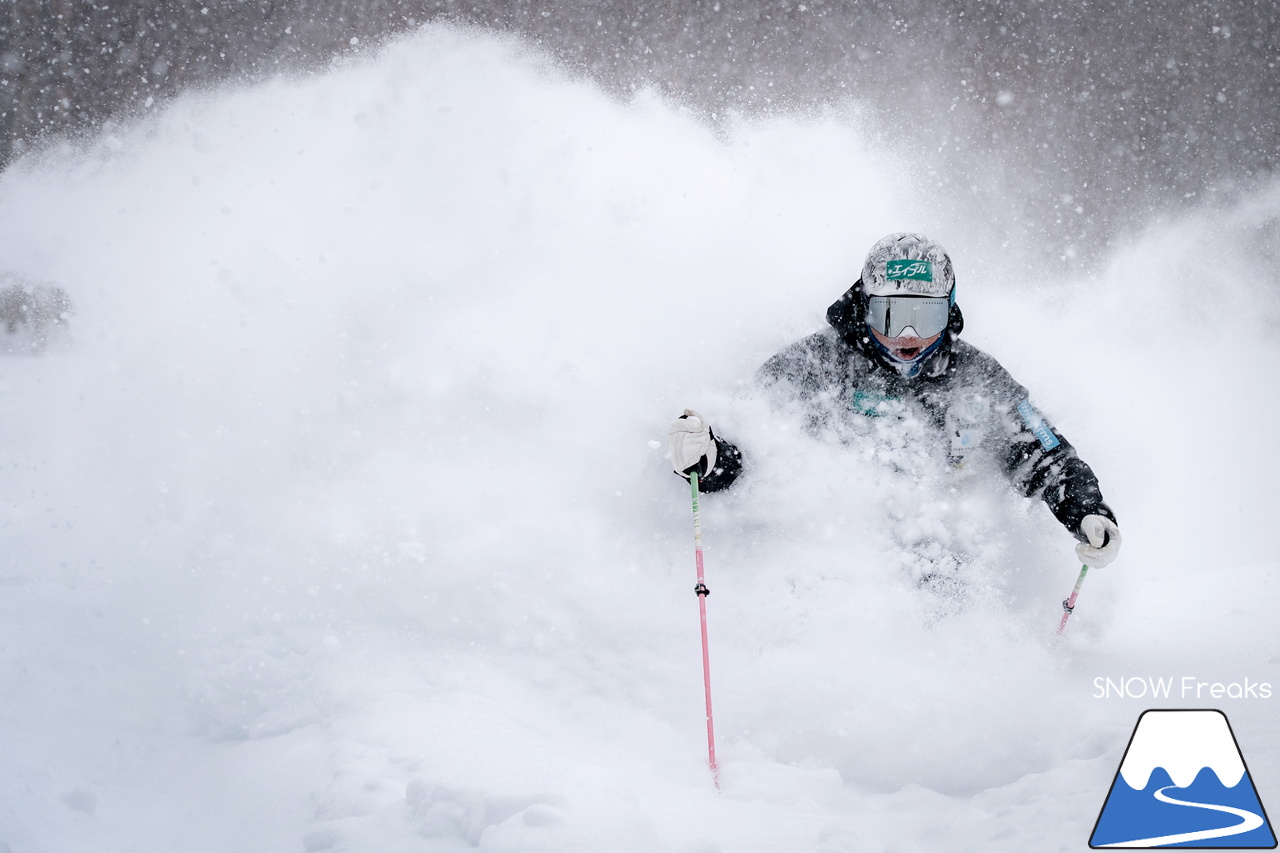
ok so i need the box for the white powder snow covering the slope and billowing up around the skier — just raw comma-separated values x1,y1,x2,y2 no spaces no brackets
0,28,1280,853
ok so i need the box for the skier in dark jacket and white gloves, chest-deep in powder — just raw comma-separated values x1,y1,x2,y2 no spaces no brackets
668,233,1120,569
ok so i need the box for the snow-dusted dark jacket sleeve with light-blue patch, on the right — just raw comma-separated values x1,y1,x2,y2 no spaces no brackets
1005,397,1116,542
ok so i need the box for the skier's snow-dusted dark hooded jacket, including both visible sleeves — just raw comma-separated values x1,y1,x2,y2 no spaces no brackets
699,283,1116,540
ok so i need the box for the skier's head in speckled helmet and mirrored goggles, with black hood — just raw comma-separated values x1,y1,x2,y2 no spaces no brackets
827,233,964,379
